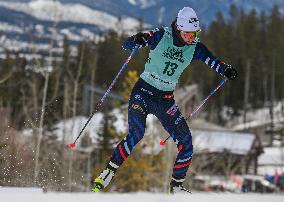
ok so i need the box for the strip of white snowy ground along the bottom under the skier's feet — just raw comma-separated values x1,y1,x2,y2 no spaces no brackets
0,192,283,202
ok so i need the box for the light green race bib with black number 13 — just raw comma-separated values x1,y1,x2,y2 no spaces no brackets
140,27,198,91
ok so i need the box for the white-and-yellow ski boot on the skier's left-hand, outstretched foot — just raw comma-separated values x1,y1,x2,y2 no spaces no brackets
92,164,116,192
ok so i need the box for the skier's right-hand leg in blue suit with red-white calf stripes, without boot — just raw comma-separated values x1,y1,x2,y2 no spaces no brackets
155,101,193,192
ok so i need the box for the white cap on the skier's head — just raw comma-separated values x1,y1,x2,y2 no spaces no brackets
177,7,200,32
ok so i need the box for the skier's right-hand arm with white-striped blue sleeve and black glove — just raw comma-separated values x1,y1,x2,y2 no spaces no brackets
193,42,237,79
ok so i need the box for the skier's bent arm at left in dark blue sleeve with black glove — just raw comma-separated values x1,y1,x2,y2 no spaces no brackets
122,28,165,49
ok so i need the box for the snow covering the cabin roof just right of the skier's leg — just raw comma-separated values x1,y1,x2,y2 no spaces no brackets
193,130,255,155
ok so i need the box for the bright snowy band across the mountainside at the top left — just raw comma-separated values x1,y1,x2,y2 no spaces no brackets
0,0,143,30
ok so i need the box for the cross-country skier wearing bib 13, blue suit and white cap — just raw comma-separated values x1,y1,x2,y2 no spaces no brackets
92,7,237,193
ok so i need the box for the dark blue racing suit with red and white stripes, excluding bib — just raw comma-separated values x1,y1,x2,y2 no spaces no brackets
108,23,229,182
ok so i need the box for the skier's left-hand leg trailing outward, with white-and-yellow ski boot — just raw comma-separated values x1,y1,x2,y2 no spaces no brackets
92,89,147,192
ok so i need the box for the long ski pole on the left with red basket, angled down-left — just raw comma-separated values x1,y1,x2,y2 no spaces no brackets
69,46,138,149
